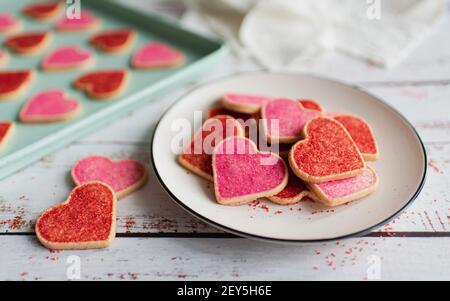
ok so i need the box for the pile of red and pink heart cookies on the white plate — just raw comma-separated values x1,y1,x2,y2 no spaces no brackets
178,92,378,206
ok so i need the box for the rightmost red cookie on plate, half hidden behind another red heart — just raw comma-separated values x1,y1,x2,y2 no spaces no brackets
333,114,378,161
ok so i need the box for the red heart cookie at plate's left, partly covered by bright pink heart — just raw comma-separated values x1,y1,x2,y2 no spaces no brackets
178,115,244,181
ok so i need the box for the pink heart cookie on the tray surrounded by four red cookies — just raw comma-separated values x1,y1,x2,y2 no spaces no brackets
41,46,93,70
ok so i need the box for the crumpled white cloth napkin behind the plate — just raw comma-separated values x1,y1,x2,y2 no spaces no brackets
185,0,445,70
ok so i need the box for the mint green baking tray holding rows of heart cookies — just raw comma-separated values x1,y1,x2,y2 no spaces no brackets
0,0,225,179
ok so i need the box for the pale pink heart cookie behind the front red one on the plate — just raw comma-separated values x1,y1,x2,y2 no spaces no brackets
261,98,320,143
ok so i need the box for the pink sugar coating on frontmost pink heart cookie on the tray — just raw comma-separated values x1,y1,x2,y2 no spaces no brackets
20,89,80,118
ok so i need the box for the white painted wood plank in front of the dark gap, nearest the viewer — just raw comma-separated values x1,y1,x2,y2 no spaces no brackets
0,236,450,280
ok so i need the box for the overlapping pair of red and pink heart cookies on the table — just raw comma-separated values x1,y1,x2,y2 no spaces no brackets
35,156,147,250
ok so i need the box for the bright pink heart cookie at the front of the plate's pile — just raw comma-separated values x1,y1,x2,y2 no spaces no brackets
212,137,288,205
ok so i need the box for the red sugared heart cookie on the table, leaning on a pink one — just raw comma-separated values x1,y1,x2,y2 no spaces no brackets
36,182,117,250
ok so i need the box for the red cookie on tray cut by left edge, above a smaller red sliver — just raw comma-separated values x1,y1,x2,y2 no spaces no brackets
0,70,33,100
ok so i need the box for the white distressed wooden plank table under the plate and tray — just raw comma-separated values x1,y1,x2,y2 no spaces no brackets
0,1,450,280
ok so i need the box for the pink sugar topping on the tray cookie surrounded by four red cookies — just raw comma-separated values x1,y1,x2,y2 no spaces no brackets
42,46,92,68
